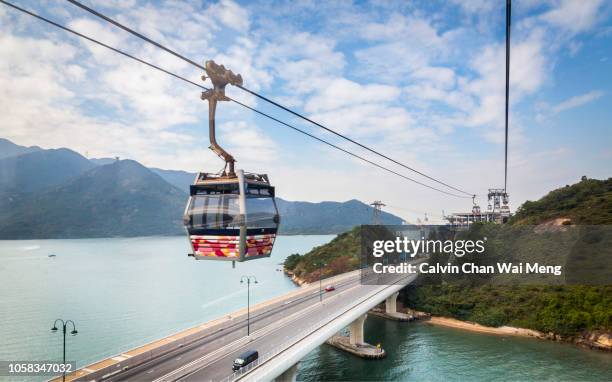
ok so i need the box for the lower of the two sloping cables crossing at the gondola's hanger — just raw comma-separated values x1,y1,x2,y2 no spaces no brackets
0,0,467,198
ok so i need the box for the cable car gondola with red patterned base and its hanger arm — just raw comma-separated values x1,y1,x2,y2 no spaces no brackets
183,61,280,264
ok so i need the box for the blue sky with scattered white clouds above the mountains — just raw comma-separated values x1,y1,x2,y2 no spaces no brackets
0,0,612,222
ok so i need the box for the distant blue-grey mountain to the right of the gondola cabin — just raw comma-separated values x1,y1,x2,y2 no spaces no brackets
276,198,403,234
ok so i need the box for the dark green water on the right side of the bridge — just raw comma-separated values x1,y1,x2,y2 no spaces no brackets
297,315,612,382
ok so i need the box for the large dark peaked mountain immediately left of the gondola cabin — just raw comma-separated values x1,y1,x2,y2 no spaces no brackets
0,160,187,239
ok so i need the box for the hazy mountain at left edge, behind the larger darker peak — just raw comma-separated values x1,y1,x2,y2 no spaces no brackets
0,149,95,194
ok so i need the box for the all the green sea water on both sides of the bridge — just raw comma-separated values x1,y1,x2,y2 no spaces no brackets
0,235,612,381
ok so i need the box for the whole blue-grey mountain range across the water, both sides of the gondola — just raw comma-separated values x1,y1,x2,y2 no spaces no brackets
0,139,402,239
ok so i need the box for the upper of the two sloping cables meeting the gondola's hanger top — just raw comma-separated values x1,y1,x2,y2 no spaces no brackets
67,0,473,197
